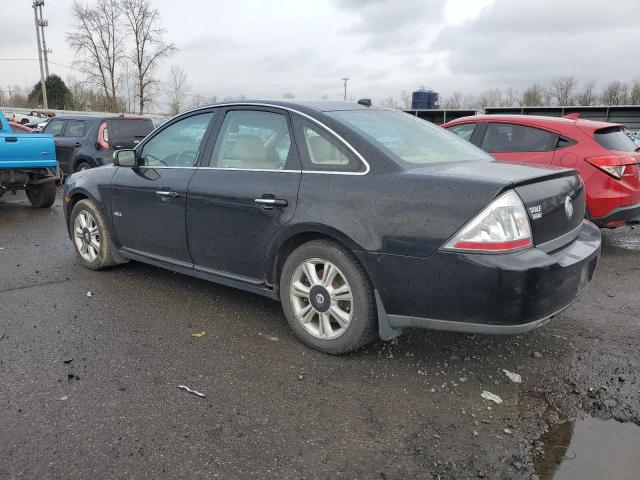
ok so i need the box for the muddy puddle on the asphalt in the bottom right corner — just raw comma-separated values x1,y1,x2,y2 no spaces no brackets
533,418,640,480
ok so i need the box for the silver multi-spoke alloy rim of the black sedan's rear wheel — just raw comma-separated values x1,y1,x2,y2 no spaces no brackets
289,258,353,340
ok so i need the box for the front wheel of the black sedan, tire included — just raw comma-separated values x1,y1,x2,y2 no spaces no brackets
69,199,117,270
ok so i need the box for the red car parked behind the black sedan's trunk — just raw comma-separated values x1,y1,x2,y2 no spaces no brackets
442,115,640,228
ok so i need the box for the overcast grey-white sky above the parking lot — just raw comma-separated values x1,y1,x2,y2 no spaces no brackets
0,0,640,109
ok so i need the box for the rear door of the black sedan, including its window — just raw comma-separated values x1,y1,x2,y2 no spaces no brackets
187,107,301,283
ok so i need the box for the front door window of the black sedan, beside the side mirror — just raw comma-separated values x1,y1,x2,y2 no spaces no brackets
140,113,213,167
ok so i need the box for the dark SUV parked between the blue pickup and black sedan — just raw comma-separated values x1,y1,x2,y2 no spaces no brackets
44,115,153,176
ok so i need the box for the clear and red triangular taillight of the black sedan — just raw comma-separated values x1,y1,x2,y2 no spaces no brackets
443,190,533,253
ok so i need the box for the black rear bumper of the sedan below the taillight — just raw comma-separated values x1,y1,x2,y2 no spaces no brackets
358,222,600,339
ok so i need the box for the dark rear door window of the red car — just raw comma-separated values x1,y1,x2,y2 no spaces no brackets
480,123,558,152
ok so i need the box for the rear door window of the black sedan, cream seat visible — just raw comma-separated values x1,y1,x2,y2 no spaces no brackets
209,110,291,170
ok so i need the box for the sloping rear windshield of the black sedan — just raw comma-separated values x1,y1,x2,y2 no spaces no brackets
328,110,493,168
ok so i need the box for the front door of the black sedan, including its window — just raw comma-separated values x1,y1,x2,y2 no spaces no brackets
111,111,214,266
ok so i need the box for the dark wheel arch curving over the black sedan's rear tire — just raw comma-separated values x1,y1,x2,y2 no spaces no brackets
265,224,371,294
